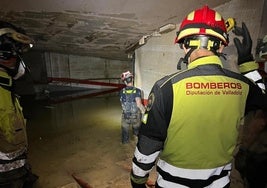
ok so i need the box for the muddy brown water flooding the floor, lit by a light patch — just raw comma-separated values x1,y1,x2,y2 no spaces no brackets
27,96,140,188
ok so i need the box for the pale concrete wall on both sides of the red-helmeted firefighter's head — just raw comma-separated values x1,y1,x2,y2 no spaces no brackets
135,0,265,99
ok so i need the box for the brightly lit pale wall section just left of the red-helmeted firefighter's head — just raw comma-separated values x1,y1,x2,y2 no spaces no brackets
135,30,181,99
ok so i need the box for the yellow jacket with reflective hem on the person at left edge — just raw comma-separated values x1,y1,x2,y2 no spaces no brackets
0,71,27,172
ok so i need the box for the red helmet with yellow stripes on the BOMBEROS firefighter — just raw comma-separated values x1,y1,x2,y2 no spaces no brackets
175,6,229,46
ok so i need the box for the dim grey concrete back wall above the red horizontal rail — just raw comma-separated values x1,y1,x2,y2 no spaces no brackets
45,53,132,79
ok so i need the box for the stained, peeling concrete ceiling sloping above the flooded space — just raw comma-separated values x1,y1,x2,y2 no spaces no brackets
0,0,230,60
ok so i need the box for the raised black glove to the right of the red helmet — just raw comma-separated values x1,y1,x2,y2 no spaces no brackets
233,22,254,65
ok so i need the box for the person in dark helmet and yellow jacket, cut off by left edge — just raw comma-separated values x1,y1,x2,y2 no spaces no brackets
0,21,37,188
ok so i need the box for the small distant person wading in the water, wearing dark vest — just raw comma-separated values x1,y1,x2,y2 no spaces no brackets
119,71,145,144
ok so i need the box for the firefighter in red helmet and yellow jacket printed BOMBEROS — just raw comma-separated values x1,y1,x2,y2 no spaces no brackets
130,6,266,188
